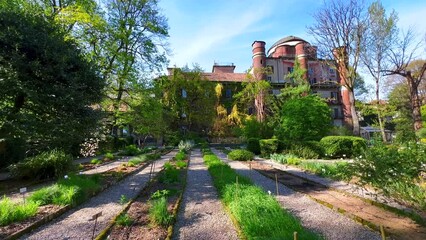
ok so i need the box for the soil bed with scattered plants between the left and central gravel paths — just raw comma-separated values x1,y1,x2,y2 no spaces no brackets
104,158,188,239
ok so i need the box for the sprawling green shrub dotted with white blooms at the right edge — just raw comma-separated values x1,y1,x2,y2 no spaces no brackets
352,143,426,210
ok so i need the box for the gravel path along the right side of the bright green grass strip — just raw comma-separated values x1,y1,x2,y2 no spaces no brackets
213,150,381,240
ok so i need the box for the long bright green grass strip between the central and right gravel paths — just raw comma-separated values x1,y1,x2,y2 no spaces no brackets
204,154,322,239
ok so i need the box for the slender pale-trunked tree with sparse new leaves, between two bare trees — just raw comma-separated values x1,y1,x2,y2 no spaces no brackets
361,1,398,142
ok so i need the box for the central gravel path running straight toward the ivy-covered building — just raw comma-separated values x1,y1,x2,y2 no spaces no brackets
173,150,238,240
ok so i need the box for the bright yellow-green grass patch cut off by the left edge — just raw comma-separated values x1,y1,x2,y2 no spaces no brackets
0,197,39,226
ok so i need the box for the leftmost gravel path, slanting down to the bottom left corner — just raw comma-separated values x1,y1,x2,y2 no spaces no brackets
21,151,176,240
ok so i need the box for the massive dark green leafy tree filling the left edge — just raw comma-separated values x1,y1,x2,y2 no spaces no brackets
0,5,105,158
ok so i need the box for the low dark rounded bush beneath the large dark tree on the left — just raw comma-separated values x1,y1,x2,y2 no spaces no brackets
9,150,73,179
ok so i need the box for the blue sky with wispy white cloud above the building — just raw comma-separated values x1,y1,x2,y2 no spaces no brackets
159,0,426,72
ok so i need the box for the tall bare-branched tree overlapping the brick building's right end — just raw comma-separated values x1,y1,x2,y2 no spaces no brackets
308,0,366,135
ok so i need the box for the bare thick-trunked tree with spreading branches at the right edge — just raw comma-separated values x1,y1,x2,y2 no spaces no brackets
385,29,426,131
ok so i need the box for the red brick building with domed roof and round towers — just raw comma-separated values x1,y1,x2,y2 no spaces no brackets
169,36,352,126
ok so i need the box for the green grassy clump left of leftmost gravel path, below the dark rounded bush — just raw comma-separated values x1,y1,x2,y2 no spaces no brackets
28,175,100,205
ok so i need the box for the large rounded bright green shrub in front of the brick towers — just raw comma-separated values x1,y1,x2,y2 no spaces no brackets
277,95,331,141
